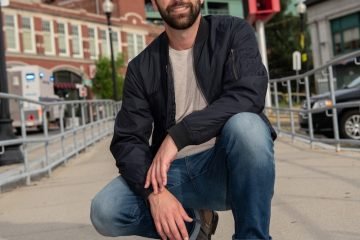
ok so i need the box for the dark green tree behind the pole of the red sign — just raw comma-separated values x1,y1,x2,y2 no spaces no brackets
265,0,312,78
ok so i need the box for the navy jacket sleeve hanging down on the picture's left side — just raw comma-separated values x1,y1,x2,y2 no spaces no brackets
110,63,153,198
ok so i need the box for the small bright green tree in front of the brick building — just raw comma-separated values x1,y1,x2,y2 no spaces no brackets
93,54,124,100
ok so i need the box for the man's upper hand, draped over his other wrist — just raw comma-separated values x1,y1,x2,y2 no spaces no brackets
145,135,178,194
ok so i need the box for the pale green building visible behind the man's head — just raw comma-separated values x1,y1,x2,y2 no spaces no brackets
145,0,244,23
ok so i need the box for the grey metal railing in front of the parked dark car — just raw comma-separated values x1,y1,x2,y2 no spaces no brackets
266,51,360,151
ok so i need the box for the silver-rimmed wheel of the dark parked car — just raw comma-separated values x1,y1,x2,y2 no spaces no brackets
340,110,360,140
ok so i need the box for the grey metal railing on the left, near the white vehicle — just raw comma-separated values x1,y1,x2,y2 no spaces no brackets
0,93,121,189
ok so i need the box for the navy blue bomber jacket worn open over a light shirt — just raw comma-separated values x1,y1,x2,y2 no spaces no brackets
110,16,276,198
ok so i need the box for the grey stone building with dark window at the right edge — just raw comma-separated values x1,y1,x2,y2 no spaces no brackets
305,0,360,93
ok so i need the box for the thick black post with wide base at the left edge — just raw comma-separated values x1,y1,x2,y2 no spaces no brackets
0,4,24,166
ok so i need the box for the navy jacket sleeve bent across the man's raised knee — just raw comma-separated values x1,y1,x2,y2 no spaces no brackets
168,21,268,150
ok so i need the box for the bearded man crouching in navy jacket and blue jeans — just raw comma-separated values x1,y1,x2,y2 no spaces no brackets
91,0,276,240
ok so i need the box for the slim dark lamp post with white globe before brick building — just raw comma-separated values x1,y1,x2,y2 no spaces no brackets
103,0,118,101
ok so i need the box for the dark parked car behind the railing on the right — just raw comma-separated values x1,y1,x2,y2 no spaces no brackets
299,76,360,140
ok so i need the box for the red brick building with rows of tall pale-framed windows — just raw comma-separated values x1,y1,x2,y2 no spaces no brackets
3,0,163,99
